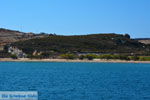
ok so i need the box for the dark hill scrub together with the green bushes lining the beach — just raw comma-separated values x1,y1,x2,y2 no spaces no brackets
0,34,150,61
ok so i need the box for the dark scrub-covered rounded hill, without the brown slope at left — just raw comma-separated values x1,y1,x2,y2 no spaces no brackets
12,34,149,54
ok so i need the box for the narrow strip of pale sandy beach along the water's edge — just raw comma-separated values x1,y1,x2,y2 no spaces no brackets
0,58,150,63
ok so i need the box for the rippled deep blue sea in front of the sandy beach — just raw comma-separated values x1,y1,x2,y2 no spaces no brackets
0,62,150,100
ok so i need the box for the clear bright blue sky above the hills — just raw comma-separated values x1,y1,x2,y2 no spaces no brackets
0,0,150,38
